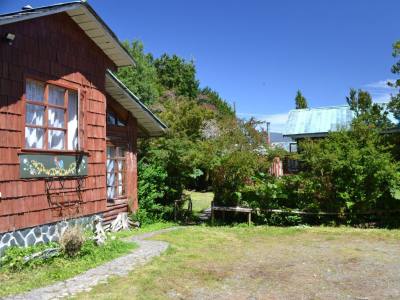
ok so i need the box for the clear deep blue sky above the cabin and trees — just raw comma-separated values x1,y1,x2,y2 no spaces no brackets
0,0,400,131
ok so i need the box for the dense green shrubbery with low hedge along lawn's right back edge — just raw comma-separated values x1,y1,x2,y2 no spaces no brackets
239,122,400,226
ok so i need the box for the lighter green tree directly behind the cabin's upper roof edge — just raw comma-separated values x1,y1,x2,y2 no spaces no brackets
117,41,160,105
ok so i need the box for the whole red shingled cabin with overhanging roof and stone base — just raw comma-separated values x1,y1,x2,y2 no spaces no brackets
0,1,166,255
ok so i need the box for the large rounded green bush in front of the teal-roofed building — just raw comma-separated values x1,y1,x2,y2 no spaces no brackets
300,124,400,217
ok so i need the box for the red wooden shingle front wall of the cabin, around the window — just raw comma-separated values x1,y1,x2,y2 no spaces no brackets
0,13,136,237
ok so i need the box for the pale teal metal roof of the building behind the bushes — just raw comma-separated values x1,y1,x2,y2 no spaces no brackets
283,105,354,138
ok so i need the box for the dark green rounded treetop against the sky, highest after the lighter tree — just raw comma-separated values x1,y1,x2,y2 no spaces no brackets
154,54,199,99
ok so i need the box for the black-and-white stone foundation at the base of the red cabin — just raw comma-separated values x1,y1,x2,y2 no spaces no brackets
0,215,100,257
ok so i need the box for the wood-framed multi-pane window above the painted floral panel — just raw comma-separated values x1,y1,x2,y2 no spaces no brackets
25,80,78,150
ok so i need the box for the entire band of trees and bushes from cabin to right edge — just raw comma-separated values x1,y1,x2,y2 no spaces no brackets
119,38,400,226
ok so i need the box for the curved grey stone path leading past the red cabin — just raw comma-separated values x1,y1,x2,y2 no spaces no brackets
1,227,177,300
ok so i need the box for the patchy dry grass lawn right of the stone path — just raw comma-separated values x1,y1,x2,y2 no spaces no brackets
76,226,400,299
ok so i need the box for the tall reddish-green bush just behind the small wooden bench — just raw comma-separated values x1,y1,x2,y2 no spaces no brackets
211,119,271,206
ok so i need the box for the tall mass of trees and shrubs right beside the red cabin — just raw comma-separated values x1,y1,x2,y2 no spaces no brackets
118,42,276,224
